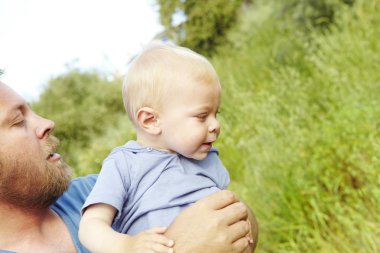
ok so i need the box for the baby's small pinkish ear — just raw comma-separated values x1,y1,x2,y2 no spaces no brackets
136,107,161,135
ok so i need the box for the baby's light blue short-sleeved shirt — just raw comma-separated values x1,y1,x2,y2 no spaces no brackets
82,141,230,235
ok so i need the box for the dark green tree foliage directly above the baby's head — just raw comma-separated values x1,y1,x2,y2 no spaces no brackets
157,0,242,55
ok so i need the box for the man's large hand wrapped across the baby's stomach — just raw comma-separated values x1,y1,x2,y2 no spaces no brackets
165,190,252,253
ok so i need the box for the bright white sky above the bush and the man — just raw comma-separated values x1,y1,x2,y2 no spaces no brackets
0,0,163,101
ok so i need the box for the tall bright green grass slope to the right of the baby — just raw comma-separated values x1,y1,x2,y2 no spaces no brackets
213,0,380,252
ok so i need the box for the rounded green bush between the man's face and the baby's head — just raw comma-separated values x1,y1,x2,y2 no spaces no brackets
32,70,124,175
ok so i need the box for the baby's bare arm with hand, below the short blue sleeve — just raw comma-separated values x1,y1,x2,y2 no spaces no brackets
79,204,174,253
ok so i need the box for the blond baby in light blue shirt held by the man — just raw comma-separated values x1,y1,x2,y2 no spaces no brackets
79,43,249,253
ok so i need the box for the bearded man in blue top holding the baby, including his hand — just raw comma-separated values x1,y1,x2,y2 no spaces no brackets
0,82,257,253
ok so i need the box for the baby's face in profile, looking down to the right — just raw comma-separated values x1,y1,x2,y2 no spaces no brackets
159,79,221,160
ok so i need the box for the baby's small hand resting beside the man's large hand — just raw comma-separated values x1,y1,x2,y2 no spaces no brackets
127,227,174,253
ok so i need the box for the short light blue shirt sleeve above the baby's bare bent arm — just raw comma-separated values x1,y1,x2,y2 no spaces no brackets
81,152,130,218
